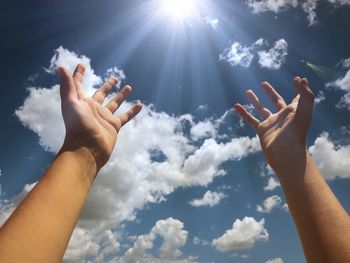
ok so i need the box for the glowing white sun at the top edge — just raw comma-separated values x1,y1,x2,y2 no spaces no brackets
157,0,197,23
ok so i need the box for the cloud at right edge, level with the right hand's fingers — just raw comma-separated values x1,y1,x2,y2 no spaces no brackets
326,58,350,110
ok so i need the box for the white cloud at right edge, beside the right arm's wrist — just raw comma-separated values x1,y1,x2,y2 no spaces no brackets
309,133,350,180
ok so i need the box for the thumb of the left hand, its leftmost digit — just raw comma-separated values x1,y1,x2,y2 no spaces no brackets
57,67,78,102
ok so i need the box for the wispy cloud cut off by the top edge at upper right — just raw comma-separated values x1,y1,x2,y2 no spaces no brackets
246,0,350,26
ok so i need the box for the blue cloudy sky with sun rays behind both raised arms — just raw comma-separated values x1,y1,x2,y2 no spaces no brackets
0,0,350,263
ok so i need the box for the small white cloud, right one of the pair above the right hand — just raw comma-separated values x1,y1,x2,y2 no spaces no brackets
258,39,288,70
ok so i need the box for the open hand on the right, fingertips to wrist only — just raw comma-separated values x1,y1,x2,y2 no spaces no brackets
234,77,314,169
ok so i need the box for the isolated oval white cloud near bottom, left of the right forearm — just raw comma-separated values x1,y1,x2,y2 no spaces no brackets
212,217,269,252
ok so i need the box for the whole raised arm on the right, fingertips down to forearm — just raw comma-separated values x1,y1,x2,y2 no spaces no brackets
235,77,350,263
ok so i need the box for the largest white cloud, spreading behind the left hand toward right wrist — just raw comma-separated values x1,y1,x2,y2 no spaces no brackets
4,47,260,262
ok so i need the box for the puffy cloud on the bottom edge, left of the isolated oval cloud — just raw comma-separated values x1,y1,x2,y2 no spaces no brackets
117,218,192,263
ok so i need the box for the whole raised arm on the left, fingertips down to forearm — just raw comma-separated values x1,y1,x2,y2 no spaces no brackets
0,64,142,263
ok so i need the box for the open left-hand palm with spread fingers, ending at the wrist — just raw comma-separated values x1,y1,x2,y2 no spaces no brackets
57,64,142,172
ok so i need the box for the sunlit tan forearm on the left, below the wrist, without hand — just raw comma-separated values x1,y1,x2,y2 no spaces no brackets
0,149,97,263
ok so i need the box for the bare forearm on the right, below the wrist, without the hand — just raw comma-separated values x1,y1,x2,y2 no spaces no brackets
275,148,350,263
